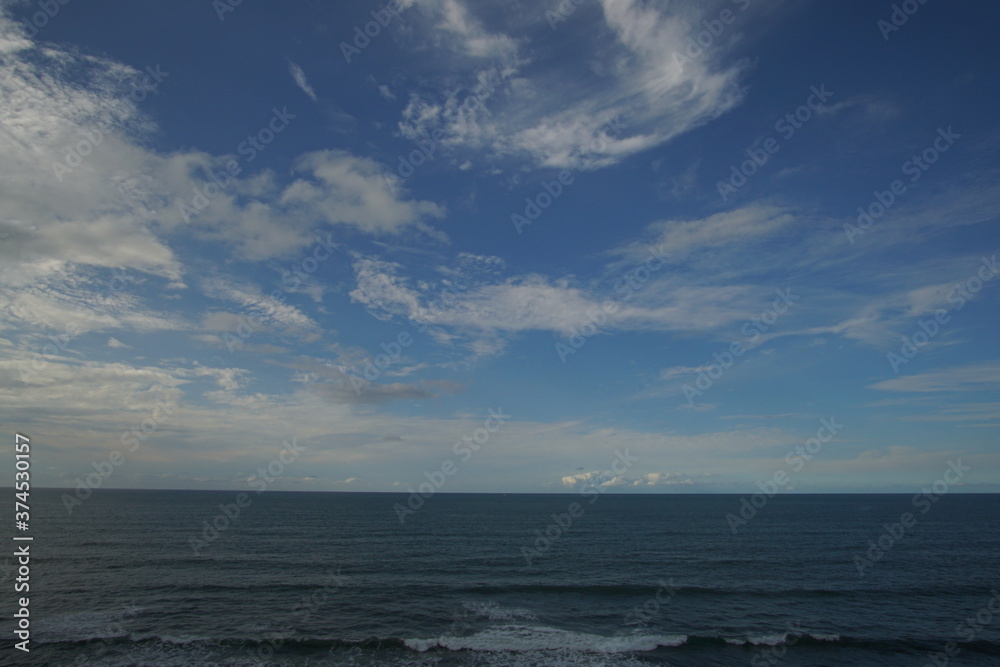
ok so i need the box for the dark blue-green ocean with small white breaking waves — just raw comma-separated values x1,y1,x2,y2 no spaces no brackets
0,490,1000,666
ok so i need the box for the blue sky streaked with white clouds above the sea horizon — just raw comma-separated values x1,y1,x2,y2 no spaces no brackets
0,0,1000,493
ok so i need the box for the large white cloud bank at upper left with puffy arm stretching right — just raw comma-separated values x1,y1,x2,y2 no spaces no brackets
0,9,444,298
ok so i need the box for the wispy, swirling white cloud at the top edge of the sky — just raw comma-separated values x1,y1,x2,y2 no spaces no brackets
400,0,743,169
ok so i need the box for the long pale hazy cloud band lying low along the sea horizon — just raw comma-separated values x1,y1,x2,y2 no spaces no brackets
0,334,972,491
